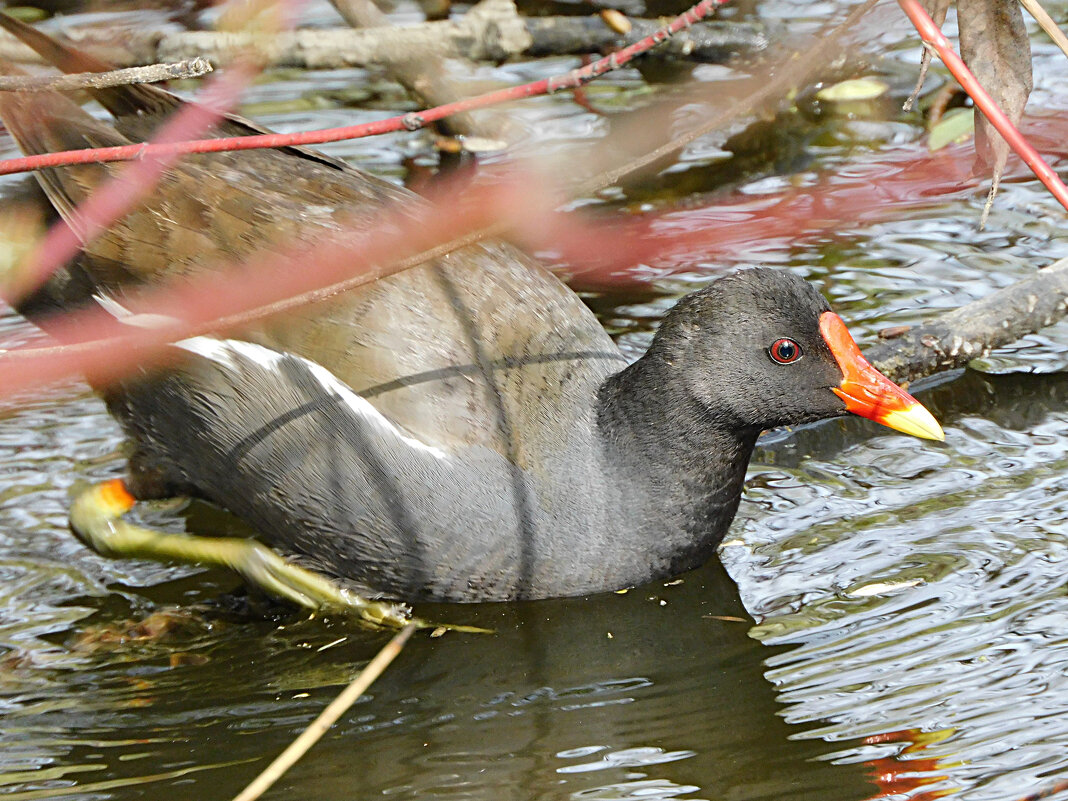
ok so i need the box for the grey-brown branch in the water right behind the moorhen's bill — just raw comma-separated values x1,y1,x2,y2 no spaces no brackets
865,258,1068,381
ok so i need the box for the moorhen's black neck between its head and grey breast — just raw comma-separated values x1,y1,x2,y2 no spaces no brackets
597,348,760,571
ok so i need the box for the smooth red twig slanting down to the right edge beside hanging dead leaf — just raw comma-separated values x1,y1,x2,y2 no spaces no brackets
897,0,1068,209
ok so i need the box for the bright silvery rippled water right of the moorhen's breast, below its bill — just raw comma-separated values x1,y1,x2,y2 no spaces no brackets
726,373,1068,799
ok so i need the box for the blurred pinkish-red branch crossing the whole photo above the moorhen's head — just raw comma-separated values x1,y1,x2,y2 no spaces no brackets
0,107,1068,395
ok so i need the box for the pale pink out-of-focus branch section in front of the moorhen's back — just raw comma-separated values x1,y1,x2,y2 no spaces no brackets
0,182,532,396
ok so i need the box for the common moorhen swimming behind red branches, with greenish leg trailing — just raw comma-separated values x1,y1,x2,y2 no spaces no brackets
0,17,943,617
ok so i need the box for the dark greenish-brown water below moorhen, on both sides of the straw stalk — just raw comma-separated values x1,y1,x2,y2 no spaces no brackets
0,542,884,799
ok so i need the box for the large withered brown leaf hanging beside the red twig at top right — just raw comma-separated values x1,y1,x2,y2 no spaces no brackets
957,0,1032,227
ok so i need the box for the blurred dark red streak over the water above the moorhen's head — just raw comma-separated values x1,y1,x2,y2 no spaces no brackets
553,112,1068,289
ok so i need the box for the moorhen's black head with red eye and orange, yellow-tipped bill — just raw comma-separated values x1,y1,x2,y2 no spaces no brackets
649,268,942,439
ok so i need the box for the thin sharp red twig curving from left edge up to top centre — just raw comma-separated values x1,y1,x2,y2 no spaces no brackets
0,0,727,175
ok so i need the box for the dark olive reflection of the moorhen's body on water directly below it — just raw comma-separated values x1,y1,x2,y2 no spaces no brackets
249,567,870,799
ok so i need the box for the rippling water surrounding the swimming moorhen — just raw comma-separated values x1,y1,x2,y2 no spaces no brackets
0,1,1068,801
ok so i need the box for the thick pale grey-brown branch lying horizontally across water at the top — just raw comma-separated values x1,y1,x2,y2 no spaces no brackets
0,13,767,69
